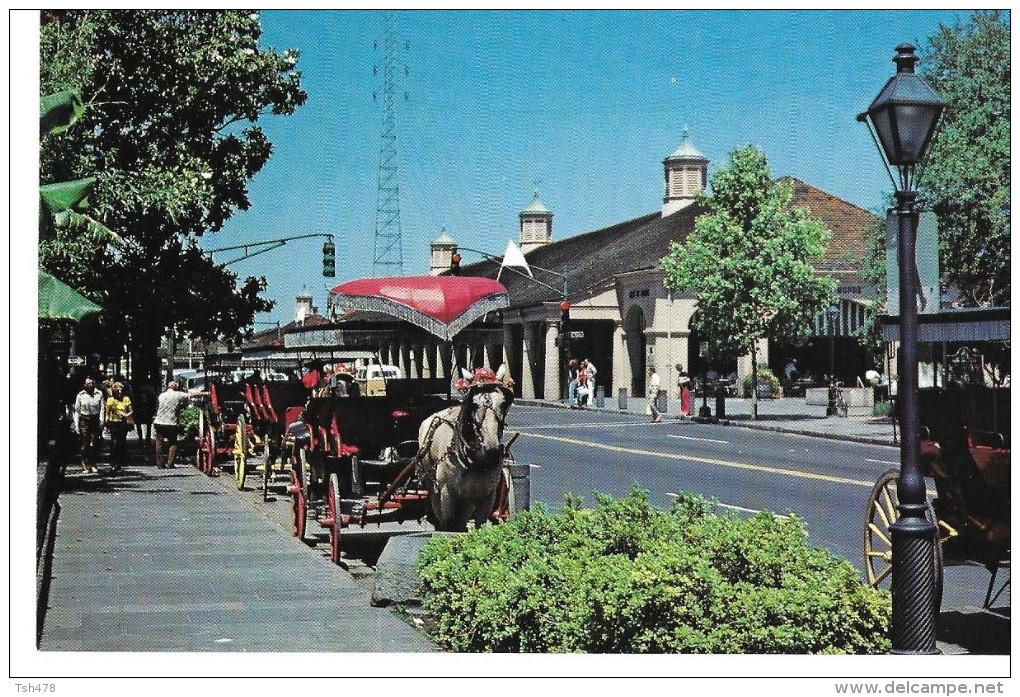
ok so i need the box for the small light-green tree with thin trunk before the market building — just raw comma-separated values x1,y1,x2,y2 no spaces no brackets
662,146,833,418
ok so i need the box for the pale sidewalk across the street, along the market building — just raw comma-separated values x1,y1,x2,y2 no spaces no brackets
516,397,899,445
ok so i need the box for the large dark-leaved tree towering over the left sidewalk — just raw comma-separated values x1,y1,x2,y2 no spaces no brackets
40,10,306,381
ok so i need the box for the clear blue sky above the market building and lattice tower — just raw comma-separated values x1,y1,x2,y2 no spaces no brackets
203,10,966,321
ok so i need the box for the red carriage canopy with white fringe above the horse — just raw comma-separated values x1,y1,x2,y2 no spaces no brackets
329,276,510,341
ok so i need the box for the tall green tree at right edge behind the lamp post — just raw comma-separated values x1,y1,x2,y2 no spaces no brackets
920,10,1010,305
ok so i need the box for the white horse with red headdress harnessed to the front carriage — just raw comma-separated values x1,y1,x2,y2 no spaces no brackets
418,383,513,532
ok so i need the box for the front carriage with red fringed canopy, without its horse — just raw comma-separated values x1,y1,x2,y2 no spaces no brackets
285,277,526,561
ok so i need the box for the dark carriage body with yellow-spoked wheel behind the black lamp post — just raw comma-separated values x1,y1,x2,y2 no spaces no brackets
864,388,1010,608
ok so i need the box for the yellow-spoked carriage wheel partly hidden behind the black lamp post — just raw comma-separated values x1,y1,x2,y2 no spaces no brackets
864,469,942,608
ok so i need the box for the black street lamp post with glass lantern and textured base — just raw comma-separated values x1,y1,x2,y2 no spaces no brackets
857,44,946,654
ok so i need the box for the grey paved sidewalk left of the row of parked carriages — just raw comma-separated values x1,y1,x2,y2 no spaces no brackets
39,440,438,653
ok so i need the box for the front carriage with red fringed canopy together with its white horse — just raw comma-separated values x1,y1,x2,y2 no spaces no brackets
285,277,526,561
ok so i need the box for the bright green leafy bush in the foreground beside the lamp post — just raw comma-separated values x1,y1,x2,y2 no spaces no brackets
418,489,890,654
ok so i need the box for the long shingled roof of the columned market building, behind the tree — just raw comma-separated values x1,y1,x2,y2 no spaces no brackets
461,177,877,308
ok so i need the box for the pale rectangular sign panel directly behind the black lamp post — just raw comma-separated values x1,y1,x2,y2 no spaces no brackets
885,210,941,315
